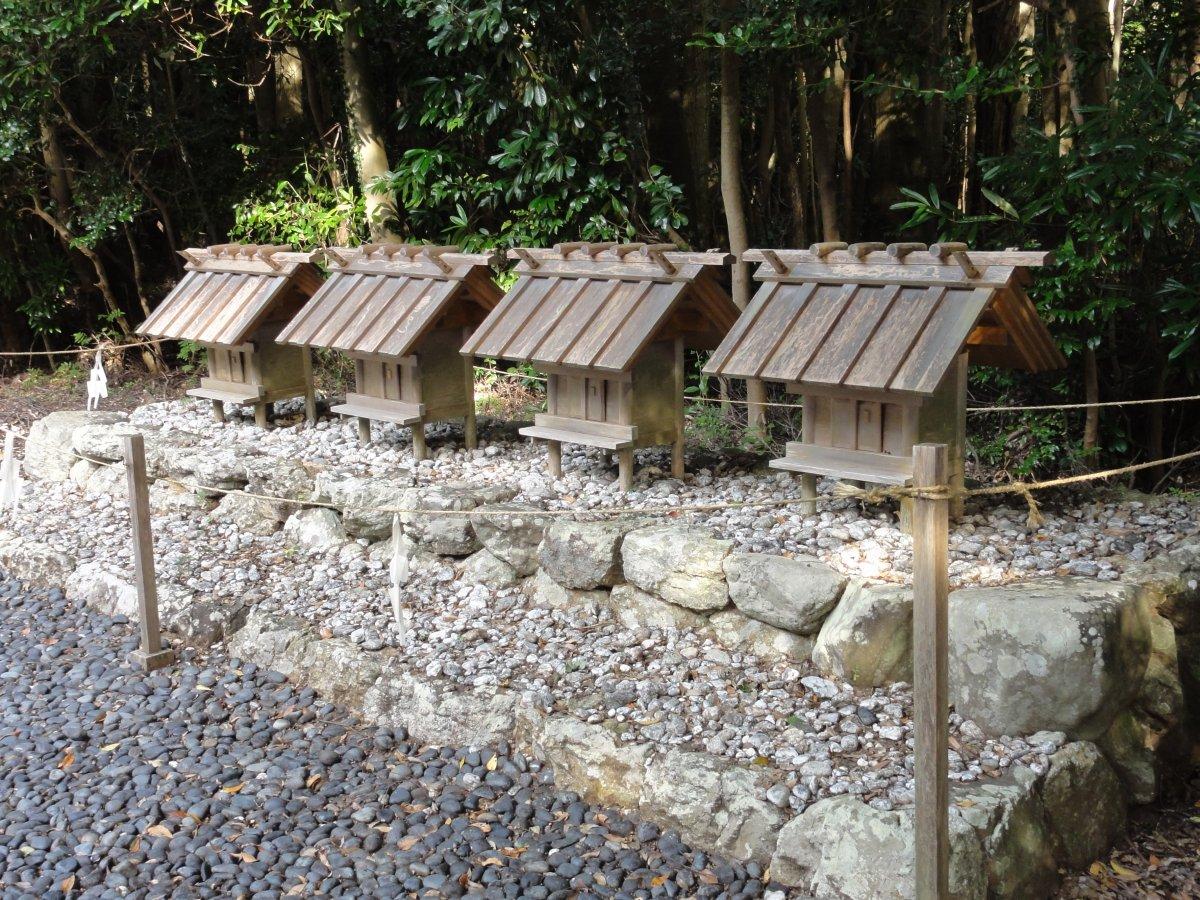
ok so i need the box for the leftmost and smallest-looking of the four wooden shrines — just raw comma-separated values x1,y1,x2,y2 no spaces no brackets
138,244,322,427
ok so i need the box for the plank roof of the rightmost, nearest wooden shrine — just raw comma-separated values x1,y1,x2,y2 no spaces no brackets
704,244,1066,396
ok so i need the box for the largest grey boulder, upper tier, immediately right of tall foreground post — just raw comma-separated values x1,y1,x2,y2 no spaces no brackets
949,578,1150,739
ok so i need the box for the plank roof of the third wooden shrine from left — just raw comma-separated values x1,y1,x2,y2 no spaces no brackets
462,242,738,372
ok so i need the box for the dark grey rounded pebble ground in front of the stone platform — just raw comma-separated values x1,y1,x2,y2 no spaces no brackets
0,575,784,898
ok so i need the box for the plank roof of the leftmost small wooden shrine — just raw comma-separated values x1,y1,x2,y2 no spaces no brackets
137,244,322,347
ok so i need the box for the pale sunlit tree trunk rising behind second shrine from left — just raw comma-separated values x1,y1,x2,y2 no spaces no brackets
338,0,397,239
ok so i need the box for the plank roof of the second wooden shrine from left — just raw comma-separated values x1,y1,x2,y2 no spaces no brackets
278,244,503,356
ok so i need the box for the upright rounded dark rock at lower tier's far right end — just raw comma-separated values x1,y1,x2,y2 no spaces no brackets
1042,740,1126,869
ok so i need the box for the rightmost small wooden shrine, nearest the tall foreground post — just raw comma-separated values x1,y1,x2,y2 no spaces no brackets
704,242,1066,515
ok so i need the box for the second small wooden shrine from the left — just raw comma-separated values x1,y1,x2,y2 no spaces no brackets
280,244,504,460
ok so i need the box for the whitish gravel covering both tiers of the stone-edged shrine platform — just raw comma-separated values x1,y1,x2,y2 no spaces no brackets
8,402,1196,809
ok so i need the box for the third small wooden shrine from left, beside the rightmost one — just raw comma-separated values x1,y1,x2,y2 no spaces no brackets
462,242,738,491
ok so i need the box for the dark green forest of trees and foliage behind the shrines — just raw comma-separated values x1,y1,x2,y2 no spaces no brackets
0,0,1200,487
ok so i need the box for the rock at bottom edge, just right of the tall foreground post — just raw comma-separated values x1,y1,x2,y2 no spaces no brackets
950,766,1058,898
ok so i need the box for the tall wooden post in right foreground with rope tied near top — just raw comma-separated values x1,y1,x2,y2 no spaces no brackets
912,444,950,900
